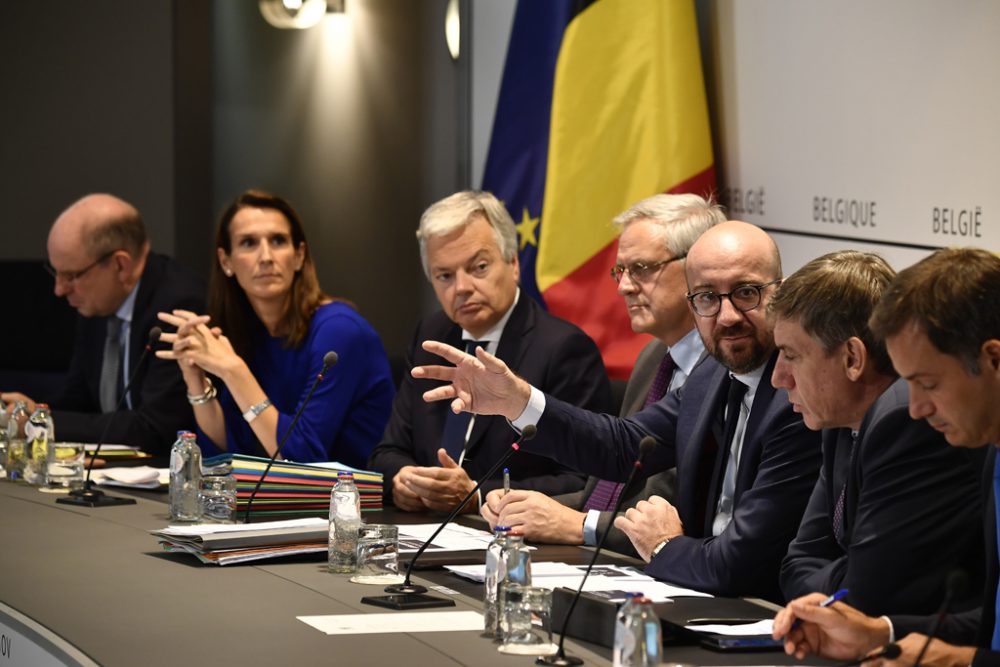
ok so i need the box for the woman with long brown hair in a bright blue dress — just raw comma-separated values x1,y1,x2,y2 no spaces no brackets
156,190,394,467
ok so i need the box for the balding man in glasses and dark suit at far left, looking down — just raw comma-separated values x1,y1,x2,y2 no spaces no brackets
2,194,204,454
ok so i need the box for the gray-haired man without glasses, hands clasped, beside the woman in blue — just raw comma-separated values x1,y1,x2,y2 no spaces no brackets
368,191,611,511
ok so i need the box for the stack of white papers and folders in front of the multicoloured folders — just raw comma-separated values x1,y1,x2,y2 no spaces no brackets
150,516,328,565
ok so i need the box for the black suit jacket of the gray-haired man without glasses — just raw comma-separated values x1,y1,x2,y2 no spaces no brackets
368,293,611,502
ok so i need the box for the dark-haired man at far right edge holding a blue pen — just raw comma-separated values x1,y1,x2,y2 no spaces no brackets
774,248,1000,667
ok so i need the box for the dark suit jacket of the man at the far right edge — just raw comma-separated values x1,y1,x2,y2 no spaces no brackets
890,445,1000,667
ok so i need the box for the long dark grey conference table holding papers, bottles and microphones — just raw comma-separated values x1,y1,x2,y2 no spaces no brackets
0,481,812,667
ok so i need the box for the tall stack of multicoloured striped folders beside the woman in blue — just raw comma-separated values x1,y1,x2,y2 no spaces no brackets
203,454,382,519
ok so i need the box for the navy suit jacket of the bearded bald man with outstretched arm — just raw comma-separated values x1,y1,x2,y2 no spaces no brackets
524,354,821,600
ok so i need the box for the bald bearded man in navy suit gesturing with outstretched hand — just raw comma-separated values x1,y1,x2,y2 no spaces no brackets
413,221,820,600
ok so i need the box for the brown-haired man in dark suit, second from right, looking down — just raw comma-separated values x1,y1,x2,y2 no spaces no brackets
768,251,982,614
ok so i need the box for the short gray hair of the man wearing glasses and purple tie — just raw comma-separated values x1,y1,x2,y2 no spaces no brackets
614,194,726,257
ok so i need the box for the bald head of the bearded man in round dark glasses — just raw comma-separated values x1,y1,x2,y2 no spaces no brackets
685,220,781,373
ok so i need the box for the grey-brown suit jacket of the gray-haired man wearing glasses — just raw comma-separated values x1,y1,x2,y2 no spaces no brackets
555,339,677,556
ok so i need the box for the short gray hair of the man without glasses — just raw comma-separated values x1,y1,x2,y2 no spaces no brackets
417,190,517,280
